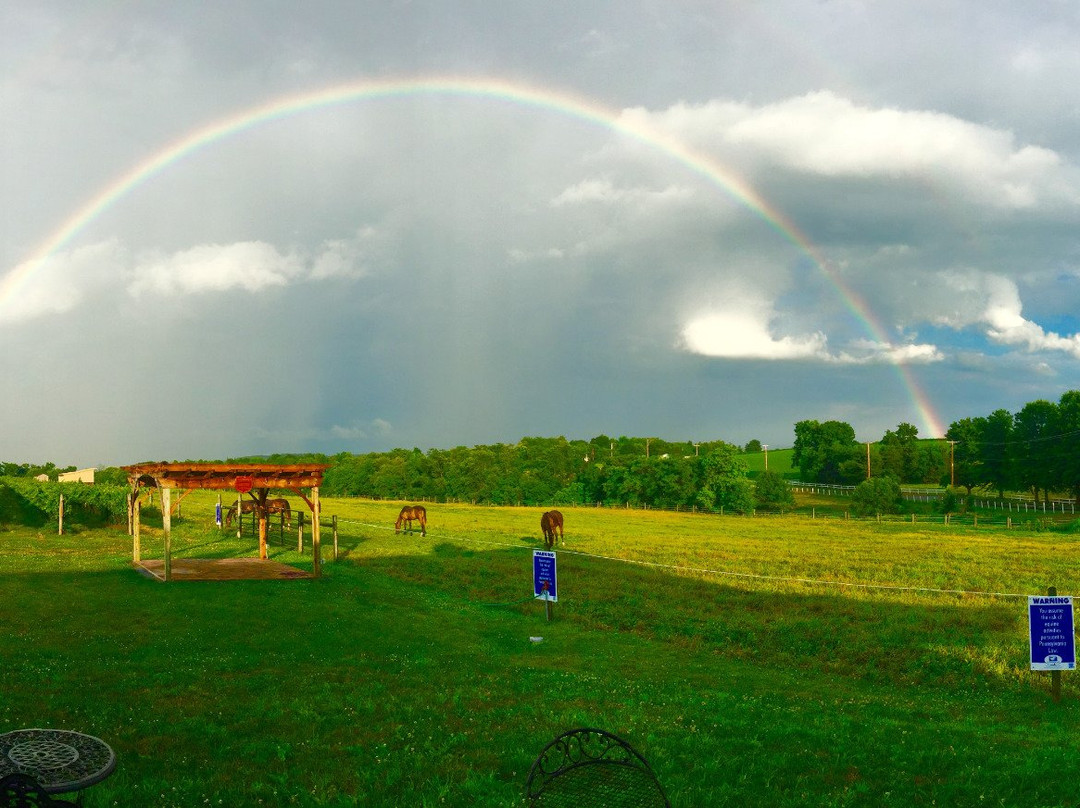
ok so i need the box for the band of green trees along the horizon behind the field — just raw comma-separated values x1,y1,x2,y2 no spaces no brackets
8,391,1080,527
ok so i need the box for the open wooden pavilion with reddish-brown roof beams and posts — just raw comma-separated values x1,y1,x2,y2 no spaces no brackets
121,462,329,581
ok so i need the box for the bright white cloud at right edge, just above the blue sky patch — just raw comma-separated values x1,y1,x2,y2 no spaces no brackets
935,271,1080,359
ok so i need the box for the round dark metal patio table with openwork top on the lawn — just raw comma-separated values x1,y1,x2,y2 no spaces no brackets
0,728,117,794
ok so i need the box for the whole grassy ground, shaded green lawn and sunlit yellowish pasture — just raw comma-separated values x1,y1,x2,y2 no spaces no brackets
0,494,1080,808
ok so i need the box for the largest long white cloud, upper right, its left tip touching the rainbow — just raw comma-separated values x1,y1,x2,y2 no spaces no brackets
623,91,1078,208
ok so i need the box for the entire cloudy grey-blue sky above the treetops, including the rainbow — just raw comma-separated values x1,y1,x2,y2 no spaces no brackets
0,0,1080,466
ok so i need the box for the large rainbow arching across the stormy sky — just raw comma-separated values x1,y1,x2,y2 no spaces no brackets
0,78,944,436
